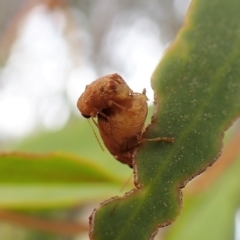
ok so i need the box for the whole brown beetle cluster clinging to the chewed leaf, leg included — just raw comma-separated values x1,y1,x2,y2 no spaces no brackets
77,74,174,167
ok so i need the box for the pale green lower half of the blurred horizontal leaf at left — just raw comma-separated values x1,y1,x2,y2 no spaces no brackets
0,183,124,210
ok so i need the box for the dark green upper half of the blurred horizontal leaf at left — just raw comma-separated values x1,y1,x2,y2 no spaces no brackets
0,152,119,184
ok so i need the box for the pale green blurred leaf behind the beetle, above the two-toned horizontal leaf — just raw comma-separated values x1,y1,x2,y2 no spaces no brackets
8,117,132,181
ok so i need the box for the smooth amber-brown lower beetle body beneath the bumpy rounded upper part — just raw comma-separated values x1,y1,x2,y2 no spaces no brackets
98,93,148,167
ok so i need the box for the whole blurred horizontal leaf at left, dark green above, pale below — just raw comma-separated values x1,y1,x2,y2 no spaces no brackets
0,152,129,209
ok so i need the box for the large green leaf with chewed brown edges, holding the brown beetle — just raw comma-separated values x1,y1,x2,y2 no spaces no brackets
91,0,240,240
